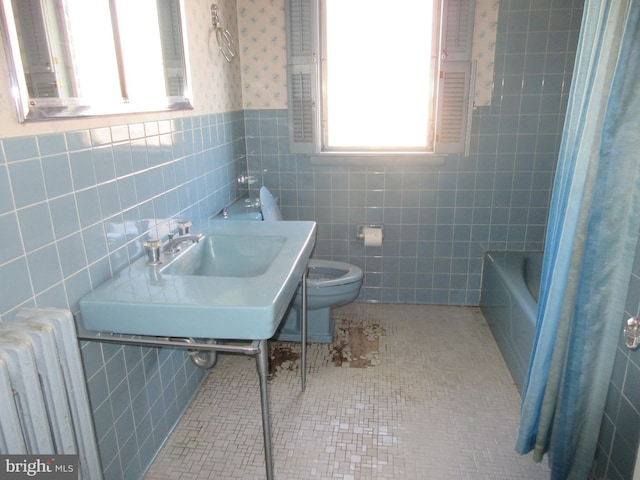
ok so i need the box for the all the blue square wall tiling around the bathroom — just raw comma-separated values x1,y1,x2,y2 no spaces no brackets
5,0,624,479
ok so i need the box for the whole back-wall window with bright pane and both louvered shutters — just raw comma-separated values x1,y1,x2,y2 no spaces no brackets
286,0,474,155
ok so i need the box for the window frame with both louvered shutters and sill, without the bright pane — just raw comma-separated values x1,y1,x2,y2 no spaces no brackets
285,0,475,165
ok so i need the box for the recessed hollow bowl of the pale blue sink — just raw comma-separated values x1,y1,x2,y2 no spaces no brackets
160,234,286,277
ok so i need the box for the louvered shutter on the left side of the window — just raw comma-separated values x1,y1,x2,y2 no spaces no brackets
285,0,319,153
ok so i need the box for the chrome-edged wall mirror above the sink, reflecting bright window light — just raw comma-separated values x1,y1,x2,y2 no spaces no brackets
2,0,191,121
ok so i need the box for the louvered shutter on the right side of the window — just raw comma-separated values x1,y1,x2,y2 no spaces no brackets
434,0,475,153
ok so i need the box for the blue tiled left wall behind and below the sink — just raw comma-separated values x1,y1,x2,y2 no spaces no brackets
0,112,246,480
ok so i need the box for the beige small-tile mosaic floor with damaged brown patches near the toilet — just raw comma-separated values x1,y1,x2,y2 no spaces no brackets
144,303,549,480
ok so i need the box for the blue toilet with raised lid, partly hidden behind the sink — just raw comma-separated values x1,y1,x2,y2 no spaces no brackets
260,187,364,343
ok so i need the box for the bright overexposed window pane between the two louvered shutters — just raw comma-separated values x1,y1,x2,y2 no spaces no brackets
322,0,435,151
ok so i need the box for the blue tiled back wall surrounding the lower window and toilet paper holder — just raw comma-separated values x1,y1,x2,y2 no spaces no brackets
245,0,582,305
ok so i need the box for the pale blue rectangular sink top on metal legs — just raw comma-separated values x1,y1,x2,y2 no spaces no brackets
80,219,316,340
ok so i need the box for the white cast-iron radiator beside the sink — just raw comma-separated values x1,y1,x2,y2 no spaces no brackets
0,308,102,480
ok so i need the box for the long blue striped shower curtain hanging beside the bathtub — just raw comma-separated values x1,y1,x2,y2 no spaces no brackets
516,0,640,479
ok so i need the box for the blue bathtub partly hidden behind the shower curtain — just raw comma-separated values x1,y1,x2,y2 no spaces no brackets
480,251,542,391
